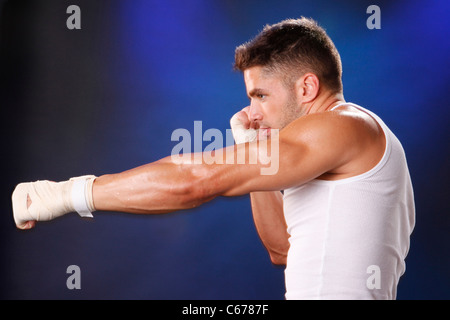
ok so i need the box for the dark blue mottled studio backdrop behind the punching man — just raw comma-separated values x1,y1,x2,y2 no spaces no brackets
0,0,450,299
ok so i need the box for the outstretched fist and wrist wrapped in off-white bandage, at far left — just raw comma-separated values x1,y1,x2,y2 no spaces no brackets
12,175,96,229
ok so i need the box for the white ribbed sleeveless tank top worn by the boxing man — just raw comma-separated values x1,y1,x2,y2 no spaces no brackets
283,103,415,299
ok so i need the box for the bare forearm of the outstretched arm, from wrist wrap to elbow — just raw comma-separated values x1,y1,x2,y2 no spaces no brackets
93,157,214,214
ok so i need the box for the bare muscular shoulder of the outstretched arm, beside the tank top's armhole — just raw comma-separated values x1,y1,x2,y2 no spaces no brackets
280,106,385,176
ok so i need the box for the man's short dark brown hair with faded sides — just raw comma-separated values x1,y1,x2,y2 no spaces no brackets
234,17,342,92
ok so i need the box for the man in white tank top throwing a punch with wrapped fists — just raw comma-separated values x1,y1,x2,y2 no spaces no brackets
12,18,415,299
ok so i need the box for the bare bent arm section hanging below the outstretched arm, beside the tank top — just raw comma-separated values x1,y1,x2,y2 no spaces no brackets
250,191,289,264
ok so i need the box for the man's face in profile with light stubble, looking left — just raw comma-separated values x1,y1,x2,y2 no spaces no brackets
244,66,301,136
